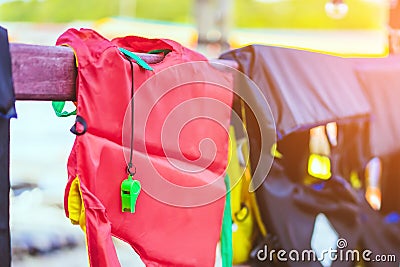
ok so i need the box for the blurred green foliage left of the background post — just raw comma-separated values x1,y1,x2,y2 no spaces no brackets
0,0,191,22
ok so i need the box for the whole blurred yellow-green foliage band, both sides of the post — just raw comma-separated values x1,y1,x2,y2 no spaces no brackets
0,0,387,29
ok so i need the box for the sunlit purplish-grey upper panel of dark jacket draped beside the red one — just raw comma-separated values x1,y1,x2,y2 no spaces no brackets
221,45,371,139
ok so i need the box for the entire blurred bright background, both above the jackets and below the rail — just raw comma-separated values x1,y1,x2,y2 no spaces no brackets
0,0,400,267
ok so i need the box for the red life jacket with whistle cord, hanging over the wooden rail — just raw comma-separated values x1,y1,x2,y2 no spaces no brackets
57,29,233,267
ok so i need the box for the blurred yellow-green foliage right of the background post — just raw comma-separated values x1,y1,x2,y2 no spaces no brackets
234,0,387,29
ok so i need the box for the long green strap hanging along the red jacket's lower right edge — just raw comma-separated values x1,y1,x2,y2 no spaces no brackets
221,175,233,267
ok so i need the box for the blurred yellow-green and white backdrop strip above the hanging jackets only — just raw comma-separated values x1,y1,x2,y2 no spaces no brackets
0,0,397,56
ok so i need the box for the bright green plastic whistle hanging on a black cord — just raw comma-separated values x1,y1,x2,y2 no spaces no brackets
121,175,142,213
